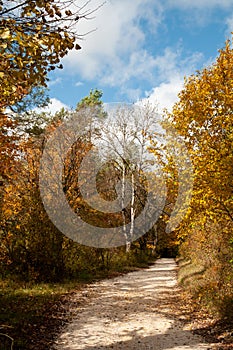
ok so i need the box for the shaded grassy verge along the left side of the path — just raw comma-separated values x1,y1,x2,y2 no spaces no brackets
0,253,156,350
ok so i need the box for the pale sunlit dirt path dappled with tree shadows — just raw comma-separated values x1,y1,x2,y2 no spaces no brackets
54,259,212,350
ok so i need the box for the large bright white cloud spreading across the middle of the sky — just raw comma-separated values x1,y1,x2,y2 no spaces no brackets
61,0,210,97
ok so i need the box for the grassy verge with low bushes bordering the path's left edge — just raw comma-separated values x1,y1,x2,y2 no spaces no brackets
0,248,154,350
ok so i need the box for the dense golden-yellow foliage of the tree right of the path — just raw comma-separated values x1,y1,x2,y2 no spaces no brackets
163,37,233,258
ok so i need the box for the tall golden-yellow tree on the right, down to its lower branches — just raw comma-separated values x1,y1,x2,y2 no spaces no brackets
168,37,233,320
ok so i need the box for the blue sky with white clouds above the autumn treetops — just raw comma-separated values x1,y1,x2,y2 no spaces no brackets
45,0,233,111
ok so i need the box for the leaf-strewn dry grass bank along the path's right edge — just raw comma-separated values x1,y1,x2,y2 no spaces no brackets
177,258,233,350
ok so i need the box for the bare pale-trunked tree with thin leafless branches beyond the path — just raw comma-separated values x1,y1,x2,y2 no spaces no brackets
100,104,160,252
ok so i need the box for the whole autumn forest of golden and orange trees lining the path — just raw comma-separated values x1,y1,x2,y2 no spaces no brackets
0,0,233,349
